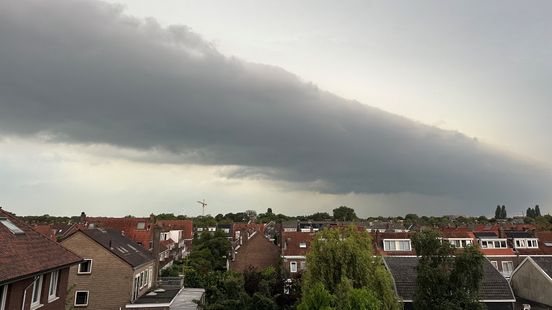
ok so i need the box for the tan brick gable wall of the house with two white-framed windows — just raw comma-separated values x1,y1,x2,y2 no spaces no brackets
61,232,134,310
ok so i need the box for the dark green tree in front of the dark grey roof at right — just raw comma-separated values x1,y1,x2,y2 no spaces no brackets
412,231,485,310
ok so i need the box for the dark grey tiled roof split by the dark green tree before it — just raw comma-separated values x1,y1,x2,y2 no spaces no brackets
383,256,515,301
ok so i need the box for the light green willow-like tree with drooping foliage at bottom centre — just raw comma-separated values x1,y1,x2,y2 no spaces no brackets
298,226,399,309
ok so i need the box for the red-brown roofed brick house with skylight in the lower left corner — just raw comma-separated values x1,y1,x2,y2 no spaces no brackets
0,208,82,310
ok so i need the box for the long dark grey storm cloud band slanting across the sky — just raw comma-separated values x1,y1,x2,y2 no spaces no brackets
0,0,551,209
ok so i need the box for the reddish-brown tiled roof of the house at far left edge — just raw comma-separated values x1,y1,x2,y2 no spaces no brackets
0,209,82,284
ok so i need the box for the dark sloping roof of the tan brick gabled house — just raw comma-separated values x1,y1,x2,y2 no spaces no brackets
80,229,154,267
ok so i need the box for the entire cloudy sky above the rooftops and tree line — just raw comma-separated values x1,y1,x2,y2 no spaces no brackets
0,0,552,217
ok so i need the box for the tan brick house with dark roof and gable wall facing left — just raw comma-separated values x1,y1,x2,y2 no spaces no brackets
61,229,157,310
